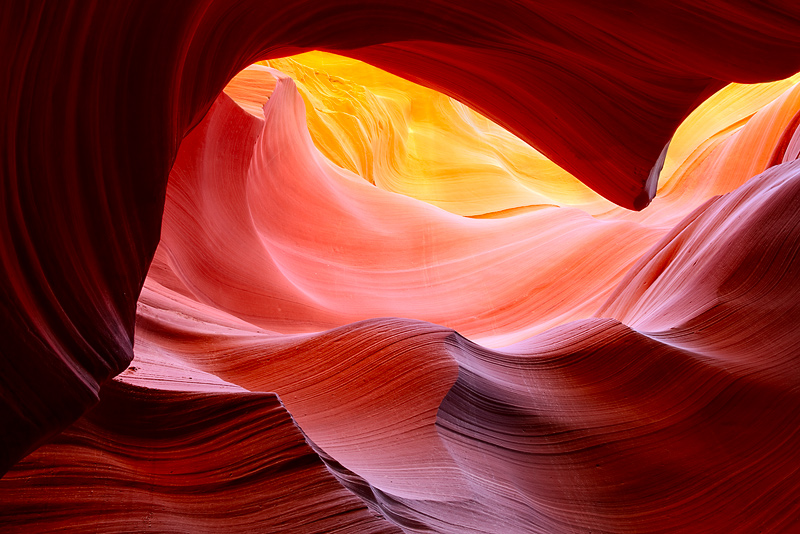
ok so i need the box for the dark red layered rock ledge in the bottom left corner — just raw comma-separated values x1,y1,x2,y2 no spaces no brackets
0,384,400,534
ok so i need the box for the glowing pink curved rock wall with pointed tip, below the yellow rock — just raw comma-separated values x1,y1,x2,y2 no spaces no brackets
159,69,663,344
